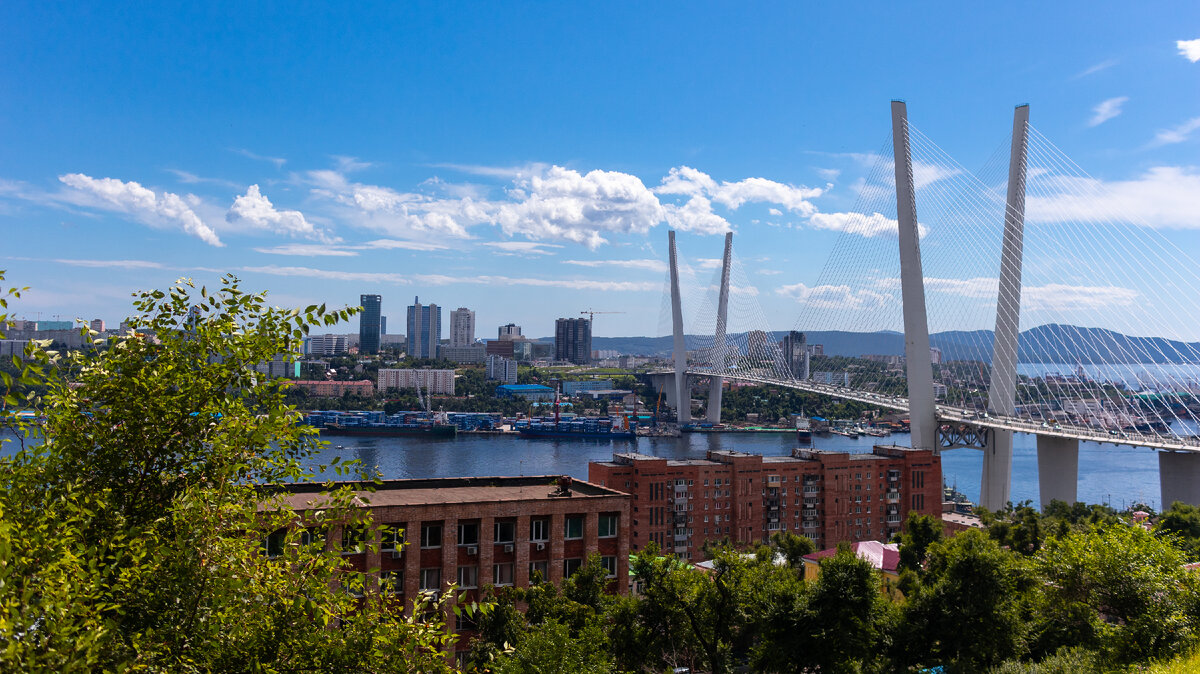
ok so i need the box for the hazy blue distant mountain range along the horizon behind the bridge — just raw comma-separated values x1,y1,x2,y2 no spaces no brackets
554,324,1200,365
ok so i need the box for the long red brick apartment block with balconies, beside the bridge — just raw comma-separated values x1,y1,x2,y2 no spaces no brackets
588,446,942,560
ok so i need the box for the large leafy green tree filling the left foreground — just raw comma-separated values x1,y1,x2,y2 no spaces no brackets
0,277,475,672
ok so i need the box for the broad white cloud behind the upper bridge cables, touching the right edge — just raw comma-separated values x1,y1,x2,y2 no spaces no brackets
1025,167,1200,229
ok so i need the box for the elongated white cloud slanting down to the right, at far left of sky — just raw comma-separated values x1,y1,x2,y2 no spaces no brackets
59,173,224,246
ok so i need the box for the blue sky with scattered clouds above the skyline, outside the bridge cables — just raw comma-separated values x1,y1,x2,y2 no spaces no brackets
0,1,1200,337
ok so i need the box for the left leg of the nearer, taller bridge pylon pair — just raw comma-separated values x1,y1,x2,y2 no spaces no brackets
892,101,940,452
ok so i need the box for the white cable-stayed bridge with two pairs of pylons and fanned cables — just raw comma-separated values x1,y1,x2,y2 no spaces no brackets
656,101,1200,508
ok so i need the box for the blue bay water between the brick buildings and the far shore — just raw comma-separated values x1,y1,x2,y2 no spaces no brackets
304,424,1159,508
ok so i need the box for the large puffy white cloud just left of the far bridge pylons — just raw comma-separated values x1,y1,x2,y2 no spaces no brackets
492,167,665,249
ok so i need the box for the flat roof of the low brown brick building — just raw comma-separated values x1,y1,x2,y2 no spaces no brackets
264,475,629,510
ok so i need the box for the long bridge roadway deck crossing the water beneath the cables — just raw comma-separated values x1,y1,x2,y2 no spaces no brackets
650,368,1200,452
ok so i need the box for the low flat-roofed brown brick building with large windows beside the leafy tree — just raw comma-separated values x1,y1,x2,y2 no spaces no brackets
268,476,630,603
